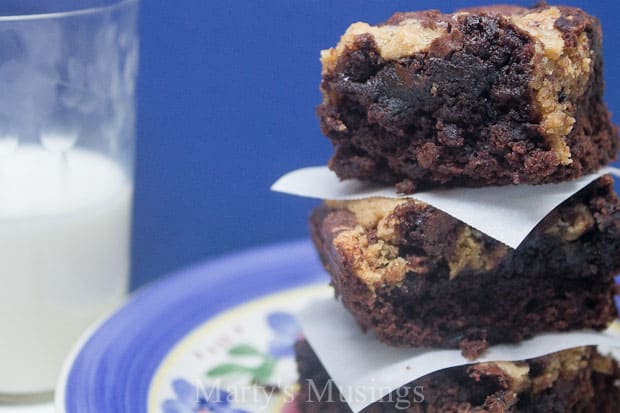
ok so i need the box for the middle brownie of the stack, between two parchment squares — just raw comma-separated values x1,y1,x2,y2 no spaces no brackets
310,175,620,358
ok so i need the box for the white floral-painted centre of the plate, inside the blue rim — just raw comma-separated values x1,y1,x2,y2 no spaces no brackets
149,286,333,413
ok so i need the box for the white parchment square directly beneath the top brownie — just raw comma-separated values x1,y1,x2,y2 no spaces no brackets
271,166,620,248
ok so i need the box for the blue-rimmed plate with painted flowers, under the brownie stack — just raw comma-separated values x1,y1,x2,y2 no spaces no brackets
56,241,333,413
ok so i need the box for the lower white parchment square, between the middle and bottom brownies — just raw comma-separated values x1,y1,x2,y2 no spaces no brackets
298,298,620,413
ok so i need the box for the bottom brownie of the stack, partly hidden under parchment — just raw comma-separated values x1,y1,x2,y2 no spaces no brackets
295,340,620,413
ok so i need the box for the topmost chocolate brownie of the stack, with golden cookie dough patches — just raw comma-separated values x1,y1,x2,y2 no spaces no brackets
317,5,618,192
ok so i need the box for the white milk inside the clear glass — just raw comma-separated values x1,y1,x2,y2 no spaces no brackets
0,146,132,394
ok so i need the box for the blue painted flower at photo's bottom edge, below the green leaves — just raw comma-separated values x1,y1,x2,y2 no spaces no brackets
162,379,249,413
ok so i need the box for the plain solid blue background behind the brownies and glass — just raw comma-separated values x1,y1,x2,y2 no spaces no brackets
133,0,620,287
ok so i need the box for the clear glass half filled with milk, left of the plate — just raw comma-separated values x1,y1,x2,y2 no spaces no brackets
0,0,138,403
